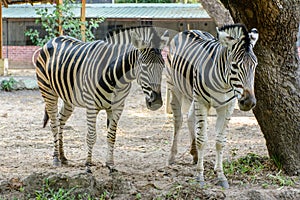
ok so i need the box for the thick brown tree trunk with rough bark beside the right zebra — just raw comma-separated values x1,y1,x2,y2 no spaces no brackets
213,0,300,175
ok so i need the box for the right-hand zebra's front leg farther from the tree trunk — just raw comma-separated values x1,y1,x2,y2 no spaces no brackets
194,100,209,187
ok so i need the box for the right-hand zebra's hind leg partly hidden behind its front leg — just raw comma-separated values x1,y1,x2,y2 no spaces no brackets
188,103,198,164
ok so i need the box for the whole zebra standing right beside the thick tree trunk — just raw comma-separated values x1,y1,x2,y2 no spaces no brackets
167,24,258,188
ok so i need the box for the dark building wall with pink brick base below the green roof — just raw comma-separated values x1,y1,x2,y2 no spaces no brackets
3,19,216,68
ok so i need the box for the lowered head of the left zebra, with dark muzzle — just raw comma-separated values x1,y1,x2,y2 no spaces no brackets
131,31,169,110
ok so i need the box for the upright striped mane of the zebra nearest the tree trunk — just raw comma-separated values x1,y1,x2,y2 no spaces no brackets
219,24,251,52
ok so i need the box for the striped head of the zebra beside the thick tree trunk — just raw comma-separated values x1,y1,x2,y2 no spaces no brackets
217,24,258,111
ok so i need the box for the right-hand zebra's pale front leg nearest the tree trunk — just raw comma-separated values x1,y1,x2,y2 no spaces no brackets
215,102,235,189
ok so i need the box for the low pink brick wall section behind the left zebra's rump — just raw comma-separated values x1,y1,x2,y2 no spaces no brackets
2,46,40,69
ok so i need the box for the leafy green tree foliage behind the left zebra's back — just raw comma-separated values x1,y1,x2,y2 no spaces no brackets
25,0,104,46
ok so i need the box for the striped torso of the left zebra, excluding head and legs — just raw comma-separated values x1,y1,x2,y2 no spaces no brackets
36,36,137,107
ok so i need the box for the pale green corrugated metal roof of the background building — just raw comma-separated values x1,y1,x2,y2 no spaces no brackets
2,3,210,19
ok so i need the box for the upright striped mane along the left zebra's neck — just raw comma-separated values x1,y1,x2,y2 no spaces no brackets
105,26,161,48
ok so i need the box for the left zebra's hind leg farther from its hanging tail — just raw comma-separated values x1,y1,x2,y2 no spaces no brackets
58,102,74,164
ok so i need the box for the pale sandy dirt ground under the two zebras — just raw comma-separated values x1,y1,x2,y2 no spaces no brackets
0,74,300,199
